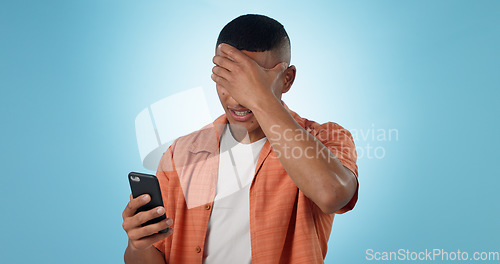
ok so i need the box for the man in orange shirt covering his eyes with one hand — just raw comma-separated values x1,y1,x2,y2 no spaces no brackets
123,15,358,264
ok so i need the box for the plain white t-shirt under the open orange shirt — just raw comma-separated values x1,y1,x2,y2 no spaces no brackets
204,126,266,264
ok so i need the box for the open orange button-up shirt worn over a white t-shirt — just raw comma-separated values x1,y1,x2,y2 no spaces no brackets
154,102,358,264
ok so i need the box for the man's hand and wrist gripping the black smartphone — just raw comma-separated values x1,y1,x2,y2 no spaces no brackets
122,194,173,264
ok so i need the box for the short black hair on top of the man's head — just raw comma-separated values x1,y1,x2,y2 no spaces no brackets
216,14,290,52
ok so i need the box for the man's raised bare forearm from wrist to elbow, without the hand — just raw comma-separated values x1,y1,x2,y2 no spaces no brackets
252,98,357,214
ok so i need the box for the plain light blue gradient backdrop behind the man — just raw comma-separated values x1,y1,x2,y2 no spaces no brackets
0,0,500,263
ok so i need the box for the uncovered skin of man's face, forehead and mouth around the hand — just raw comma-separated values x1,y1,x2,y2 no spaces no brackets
217,50,282,142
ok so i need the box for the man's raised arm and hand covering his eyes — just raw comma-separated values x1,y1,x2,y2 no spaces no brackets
212,44,357,214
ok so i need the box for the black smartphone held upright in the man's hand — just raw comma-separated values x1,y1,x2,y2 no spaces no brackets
128,172,169,233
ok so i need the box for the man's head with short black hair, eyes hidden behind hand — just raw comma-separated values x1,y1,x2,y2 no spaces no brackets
212,15,296,142
